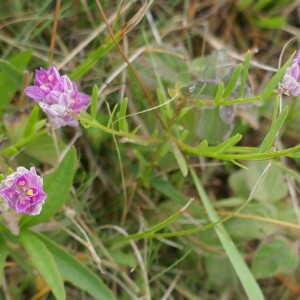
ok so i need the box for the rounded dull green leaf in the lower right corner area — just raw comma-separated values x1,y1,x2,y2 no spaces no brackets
252,238,299,279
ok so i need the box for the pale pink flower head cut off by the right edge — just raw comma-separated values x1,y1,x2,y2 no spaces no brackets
281,50,300,96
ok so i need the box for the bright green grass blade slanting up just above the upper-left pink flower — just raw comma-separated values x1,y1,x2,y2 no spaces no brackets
69,32,122,80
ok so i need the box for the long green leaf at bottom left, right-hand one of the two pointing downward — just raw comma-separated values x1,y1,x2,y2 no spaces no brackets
35,233,115,300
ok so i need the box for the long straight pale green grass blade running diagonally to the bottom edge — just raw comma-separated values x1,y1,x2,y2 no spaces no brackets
190,168,264,300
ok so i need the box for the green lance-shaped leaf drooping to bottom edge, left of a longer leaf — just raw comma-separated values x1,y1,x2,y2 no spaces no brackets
20,230,66,300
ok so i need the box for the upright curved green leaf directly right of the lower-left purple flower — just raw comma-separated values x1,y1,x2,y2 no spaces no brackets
20,148,77,227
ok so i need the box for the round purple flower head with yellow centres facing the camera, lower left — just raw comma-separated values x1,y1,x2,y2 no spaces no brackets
0,167,47,216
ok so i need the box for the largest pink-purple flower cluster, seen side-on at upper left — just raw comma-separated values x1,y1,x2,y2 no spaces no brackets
25,67,90,128
